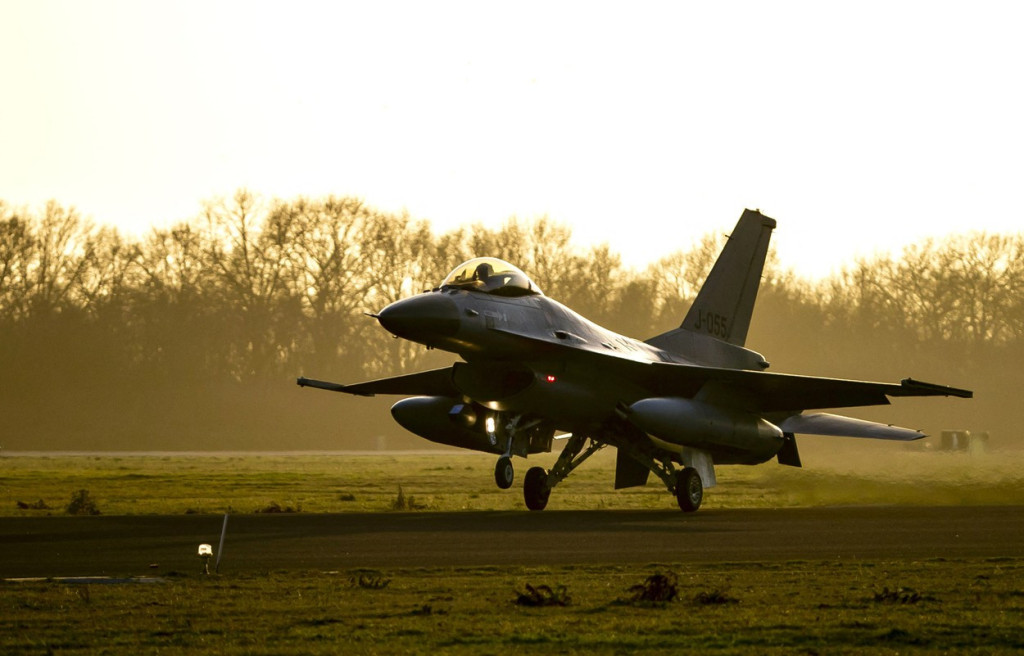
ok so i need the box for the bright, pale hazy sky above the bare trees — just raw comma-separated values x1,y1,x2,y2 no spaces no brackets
0,0,1024,274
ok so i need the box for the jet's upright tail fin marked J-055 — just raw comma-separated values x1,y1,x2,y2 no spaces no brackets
679,210,775,346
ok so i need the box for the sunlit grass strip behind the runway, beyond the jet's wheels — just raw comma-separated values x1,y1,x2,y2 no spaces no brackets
0,440,1024,516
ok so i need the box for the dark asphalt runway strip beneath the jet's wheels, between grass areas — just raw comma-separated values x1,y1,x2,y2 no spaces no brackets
0,507,1024,578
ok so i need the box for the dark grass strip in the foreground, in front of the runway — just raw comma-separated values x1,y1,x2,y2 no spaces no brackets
0,559,1024,654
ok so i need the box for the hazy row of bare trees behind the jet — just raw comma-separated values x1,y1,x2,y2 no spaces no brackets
0,190,1024,449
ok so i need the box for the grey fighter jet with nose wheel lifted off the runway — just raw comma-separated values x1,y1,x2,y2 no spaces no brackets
298,210,973,512
